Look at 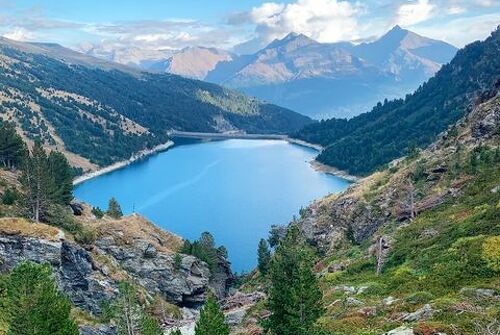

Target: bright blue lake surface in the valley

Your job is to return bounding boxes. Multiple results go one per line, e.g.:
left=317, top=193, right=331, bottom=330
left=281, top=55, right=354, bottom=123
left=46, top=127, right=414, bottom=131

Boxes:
left=75, top=140, right=349, bottom=271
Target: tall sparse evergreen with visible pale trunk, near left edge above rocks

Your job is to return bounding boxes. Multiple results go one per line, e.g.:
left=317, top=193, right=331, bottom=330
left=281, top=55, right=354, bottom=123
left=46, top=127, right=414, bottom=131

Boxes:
left=21, top=142, right=55, bottom=222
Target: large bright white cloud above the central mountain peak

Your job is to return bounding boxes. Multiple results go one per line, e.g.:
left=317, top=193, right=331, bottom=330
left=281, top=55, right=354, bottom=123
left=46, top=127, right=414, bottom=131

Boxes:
left=229, top=0, right=364, bottom=51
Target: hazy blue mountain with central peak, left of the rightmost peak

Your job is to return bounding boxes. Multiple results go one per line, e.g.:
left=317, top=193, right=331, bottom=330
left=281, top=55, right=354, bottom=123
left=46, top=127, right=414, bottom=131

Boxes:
left=206, top=33, right=394, bottom=117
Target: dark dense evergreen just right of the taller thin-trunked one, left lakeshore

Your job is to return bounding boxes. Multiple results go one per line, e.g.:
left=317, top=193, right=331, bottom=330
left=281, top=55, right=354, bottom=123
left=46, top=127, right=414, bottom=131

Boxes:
left=48, top=151, right=73, bottom=205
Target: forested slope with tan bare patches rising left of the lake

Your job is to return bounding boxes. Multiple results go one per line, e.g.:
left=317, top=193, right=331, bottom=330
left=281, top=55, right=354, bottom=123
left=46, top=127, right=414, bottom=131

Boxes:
left=0, top=39, right=310, bottom=168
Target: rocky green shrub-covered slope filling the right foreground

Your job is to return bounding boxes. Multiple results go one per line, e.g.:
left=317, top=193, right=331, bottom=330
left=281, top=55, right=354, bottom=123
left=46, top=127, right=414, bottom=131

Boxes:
left=240, top=89, right=500, bottom=335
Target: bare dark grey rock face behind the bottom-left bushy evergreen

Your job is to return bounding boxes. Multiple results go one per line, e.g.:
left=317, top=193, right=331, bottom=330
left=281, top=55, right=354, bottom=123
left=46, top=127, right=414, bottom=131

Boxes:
left=0, top=234, right=117, bottom=314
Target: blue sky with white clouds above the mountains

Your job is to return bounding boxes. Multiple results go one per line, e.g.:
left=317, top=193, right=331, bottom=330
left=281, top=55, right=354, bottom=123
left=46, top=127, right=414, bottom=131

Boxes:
left=0, top=0, right=500, bottom=52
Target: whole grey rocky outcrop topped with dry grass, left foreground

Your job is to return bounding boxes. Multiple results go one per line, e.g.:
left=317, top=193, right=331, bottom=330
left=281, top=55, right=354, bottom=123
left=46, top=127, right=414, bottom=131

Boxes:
left=0, top=210, right=232, bottom=334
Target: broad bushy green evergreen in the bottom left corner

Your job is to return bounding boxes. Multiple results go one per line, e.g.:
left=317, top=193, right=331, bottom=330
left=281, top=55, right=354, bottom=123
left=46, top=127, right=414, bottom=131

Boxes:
left=5, top=262, right=79, bottom=335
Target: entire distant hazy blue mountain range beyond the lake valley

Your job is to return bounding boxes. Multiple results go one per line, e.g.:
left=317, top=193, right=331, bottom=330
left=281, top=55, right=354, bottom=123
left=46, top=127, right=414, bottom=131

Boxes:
left=81, top=26, right=457, bottom=119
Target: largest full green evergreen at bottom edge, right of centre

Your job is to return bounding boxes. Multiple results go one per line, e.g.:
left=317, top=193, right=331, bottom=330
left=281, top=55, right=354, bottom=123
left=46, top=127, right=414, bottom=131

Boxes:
left=264, top=226, right=324, bottom=335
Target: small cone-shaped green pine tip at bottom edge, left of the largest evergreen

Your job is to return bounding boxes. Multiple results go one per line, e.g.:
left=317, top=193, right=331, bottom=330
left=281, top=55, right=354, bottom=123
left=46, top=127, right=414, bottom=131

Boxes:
left=194, top=296, right=229, bottom=335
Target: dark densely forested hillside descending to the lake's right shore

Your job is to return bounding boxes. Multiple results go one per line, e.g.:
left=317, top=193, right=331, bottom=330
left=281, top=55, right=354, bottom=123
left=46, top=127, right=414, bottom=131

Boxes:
left=294, top=29, right=500, bottom=175
